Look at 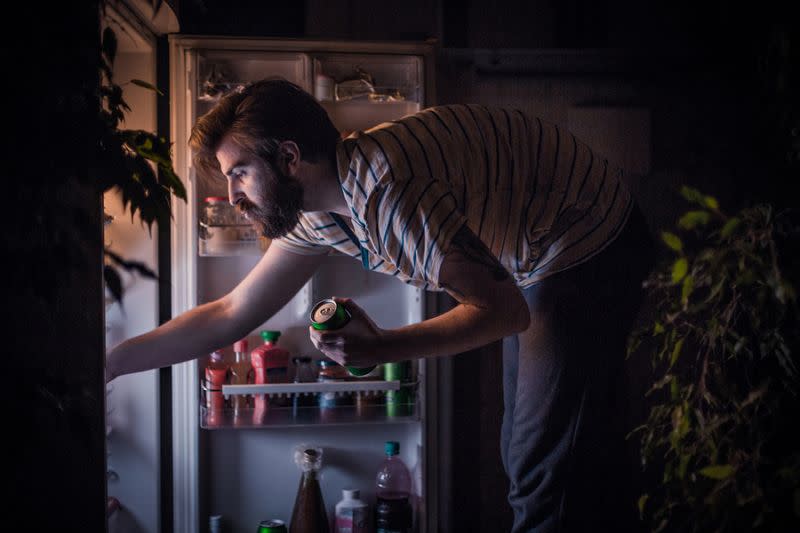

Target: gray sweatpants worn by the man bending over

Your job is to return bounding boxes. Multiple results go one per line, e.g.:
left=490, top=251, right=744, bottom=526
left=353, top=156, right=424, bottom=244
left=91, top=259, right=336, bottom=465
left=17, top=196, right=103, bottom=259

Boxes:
left=501, top=205, right=654, bottom=533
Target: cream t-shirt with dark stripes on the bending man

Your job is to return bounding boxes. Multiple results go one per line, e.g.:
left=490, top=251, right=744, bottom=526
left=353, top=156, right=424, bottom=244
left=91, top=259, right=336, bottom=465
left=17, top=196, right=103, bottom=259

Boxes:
left=274, top=105, right=633, bottom=290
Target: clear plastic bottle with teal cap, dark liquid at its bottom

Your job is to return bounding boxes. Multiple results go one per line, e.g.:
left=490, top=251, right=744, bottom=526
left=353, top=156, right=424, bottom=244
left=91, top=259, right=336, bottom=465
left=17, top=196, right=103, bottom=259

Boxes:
left=375, top=441, right=413, bottom=533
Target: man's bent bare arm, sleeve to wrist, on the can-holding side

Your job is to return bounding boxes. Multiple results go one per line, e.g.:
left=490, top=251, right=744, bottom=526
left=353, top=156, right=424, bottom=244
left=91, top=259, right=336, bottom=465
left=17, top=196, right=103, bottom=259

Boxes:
left=382, top=225, right=530, bottom=361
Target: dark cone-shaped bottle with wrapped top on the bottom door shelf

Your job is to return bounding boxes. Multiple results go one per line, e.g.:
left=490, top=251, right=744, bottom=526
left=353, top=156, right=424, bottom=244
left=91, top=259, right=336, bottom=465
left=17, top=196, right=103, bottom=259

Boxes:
left=289, top=444, right=330, bottom=533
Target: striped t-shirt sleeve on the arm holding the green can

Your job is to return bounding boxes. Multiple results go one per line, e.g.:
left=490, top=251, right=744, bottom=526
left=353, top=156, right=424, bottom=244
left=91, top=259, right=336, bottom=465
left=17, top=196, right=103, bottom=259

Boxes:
left=365, top=176, right=466, bottom=287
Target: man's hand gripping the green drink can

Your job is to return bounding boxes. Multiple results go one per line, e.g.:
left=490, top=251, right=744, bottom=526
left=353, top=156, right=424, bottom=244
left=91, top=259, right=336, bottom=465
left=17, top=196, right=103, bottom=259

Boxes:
left=308, top=297, right=386, bottom=368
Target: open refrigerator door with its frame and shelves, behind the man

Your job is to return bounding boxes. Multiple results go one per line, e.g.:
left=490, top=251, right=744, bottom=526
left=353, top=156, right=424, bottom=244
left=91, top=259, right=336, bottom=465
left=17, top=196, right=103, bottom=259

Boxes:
left=169, top=34, right=441, bottom=533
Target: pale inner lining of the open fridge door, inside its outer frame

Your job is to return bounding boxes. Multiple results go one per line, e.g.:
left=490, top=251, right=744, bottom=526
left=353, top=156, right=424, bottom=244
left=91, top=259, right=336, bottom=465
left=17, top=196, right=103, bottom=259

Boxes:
left=178, top=42, right=432, bottom=532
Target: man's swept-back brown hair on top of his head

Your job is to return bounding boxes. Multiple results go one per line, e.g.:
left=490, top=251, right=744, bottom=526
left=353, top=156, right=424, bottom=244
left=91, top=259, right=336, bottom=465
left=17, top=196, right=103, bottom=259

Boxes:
left=189, top=78, right=339, bottom=177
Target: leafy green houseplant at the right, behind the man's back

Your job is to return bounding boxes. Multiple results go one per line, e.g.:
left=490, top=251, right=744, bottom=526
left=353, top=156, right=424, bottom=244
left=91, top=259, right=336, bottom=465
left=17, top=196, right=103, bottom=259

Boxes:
left=629, top=187, right=800, bottom=532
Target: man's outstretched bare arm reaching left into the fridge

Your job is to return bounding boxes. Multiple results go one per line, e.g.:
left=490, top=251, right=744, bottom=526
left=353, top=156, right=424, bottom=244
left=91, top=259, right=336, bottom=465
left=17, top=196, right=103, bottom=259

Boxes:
left=106, top=246, right=325, bottom=381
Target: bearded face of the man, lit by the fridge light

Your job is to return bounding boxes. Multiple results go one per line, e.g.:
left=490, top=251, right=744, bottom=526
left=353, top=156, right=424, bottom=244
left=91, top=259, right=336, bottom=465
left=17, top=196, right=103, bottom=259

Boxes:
left=217, top=137, right=303, bottom=239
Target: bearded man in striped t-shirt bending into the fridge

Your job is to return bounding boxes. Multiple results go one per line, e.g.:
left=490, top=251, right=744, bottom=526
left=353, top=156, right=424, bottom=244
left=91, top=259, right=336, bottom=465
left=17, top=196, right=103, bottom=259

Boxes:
left=108, top=80, right=650, bottom=531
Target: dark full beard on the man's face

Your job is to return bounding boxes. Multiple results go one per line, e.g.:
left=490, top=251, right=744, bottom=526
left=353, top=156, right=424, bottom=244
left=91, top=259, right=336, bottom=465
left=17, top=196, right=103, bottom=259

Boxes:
left=237, top=169, right=303, bottom=239
